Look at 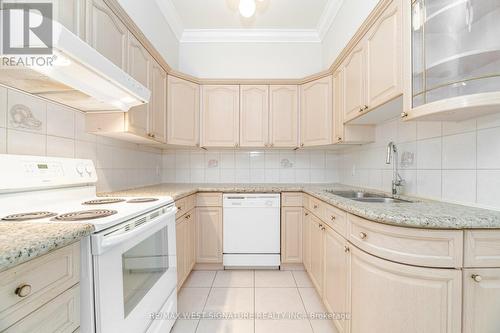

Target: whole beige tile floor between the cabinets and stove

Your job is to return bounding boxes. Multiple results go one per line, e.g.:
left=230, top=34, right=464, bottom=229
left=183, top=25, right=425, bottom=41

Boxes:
left=172, top=270, right=337, bottom=333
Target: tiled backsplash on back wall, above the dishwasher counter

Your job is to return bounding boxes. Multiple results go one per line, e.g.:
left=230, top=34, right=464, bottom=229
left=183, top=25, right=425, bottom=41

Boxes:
left=162, top=150, right=339, bottom=183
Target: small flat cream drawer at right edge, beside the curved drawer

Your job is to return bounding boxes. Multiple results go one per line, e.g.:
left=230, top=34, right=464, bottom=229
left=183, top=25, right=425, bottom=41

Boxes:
left=464, top=230, right=500, bottom=267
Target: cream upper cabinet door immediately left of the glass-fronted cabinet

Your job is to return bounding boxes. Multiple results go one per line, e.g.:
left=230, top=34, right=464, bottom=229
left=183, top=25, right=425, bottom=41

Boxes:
left=365, top=1, right=403, bottom=109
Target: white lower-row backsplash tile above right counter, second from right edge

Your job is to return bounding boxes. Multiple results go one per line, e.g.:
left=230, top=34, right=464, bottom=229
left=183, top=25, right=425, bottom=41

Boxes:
left=442, top=170, right=476, bottom=204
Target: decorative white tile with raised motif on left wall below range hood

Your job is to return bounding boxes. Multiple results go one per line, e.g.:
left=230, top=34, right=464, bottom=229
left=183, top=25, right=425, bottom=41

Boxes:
left=7, top=90, right=47, bottom=134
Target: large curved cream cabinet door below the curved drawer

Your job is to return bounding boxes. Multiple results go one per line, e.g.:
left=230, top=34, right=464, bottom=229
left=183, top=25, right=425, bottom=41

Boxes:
left=350, top=246, right=462, bottom=333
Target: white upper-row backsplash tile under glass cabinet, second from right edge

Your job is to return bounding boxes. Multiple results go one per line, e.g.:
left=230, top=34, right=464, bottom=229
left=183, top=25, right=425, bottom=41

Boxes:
left=443, top=132, right=476, bottom=169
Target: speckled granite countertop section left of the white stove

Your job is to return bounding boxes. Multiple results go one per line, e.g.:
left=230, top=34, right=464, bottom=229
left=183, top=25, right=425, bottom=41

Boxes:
left=0, top=222, right=94, bottom=271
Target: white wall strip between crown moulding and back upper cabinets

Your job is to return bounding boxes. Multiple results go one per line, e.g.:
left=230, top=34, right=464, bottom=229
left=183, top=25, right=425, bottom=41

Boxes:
left=179, top=42, right=323, bottom=79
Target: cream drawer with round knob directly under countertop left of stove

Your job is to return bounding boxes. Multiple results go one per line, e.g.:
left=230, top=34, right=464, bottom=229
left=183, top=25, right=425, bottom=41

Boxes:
left=0, top=243, right=80, bottom=331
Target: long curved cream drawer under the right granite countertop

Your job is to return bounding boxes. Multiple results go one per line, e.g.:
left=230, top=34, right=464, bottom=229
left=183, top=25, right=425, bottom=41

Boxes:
left=348, top=214, right=463, bottom=267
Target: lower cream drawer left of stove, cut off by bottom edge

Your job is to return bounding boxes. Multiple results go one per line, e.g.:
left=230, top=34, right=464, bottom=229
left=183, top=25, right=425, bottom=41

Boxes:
left=3, top=285, right=80, bottom=333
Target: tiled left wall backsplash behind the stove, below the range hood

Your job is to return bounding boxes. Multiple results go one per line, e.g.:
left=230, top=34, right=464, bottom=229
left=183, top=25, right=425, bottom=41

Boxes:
left=0, top=86, right=161, bottom=191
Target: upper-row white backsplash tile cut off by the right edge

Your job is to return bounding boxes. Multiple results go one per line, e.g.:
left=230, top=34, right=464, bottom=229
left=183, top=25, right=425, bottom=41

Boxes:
left=477, top=127, right=500, bottom=169
